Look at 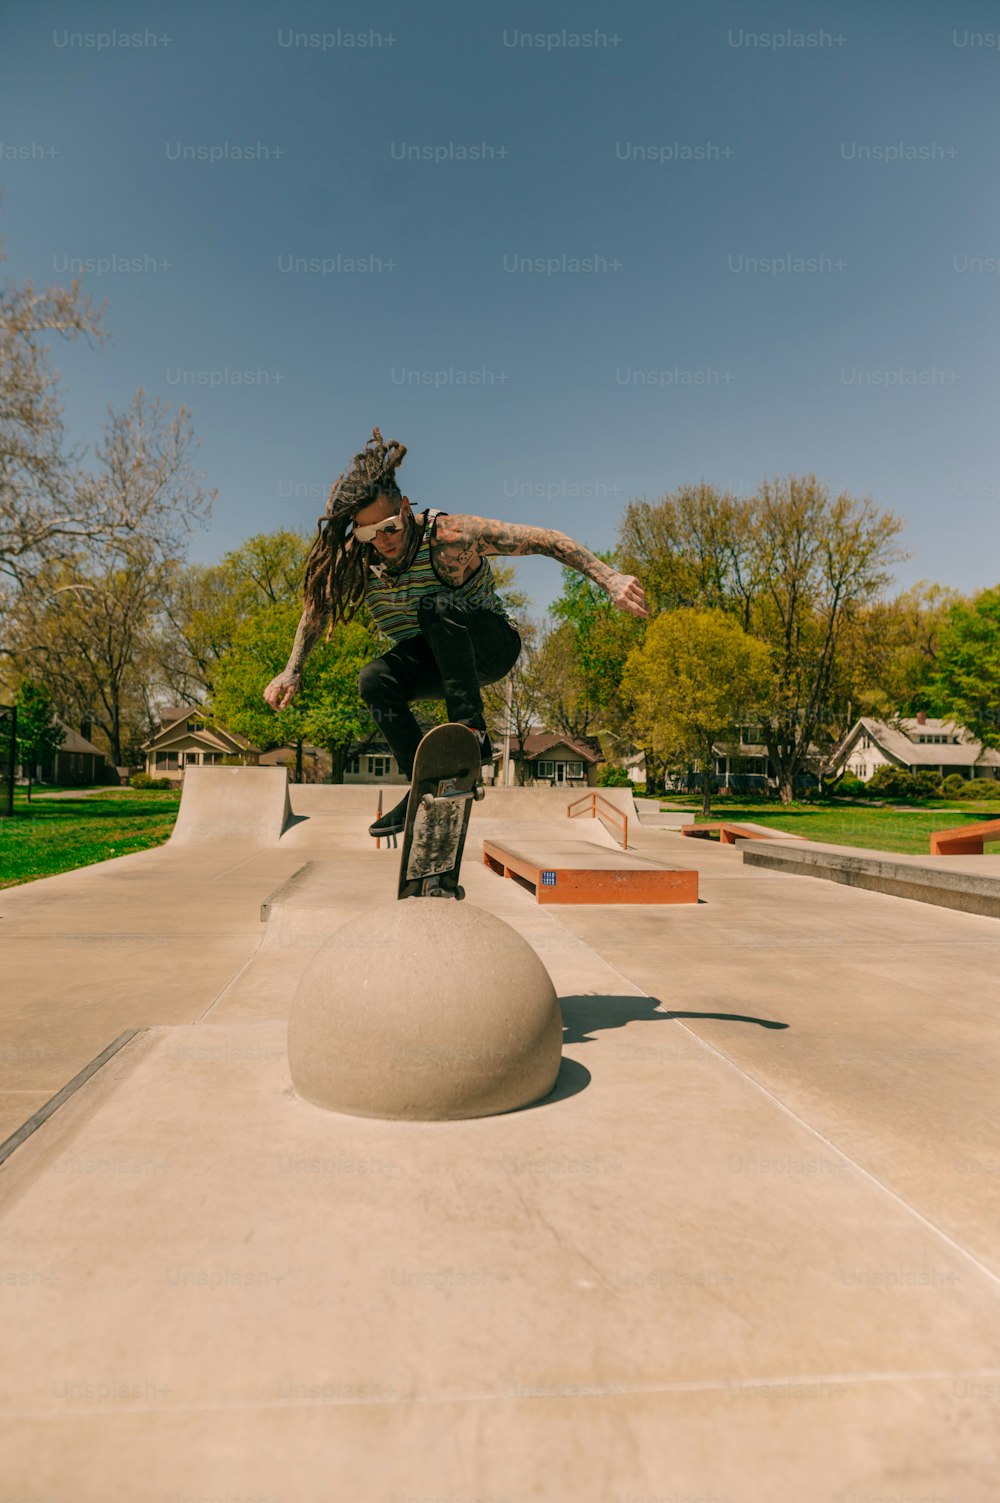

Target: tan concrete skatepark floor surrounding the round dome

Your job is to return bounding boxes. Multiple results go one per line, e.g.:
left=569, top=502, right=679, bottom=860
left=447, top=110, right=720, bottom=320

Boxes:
left=0, top=770, right=1000, bottom=1503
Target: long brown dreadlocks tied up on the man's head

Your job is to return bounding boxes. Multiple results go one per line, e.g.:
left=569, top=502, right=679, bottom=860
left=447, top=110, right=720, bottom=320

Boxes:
left=304, top=428, right=406, bottom=642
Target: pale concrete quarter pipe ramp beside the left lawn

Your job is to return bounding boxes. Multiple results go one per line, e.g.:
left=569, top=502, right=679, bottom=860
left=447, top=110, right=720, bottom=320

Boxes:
left=168, top=767, right=290, bottom=846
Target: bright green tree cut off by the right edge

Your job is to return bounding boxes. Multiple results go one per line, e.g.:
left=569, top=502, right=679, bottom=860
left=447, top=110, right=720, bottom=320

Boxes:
left=926, top=585, right=1000, bottom=747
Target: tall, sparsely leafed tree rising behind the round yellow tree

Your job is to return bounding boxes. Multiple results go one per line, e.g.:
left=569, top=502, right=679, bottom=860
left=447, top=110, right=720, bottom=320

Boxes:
left=621, top=475, right=905, bottom=803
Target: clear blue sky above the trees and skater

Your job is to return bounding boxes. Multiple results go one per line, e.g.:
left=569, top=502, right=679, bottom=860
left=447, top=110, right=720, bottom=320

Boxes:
left=0, top=0, right=1000, bottom=615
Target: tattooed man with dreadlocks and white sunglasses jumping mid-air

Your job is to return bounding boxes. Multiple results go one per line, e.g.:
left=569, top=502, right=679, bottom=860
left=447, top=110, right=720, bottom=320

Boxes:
left=263, top=428, right=650, bottom=836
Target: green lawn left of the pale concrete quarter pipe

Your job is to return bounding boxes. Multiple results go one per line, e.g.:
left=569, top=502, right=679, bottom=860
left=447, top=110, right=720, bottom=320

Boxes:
left=0, top=788, right=180, bottom=888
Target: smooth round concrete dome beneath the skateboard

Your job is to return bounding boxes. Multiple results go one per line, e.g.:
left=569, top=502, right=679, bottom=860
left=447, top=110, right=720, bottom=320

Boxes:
left=289, top=897, right=562, bottom=1120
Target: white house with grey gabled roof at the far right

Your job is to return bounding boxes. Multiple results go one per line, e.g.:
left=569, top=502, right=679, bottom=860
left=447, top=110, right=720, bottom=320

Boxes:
left=829, top=711, right=1000, bottom=783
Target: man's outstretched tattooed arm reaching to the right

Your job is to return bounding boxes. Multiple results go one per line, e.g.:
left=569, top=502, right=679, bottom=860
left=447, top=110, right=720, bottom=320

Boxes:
left=430, top=516, right=650, bottom=616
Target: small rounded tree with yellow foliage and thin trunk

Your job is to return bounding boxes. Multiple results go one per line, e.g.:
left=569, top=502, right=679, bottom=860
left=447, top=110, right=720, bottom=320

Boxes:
left=623, top=607, right=774, bottom=818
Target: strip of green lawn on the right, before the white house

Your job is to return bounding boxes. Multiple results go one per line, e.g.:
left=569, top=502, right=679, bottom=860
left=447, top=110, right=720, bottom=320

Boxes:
left=663, top=794, right=1000, bottom=855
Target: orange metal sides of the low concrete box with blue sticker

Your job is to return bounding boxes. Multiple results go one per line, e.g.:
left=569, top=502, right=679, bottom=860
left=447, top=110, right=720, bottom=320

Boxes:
left=483, top=840, right=698, bottom=903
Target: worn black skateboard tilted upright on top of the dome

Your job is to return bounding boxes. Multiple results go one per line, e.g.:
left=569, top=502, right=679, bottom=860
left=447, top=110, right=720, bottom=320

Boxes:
left=397, top=724, right=486, bottom=897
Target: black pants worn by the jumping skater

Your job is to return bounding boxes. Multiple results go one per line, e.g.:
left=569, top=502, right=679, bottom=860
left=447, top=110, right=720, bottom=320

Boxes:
left=358, top=589, right=520, bottom=777
